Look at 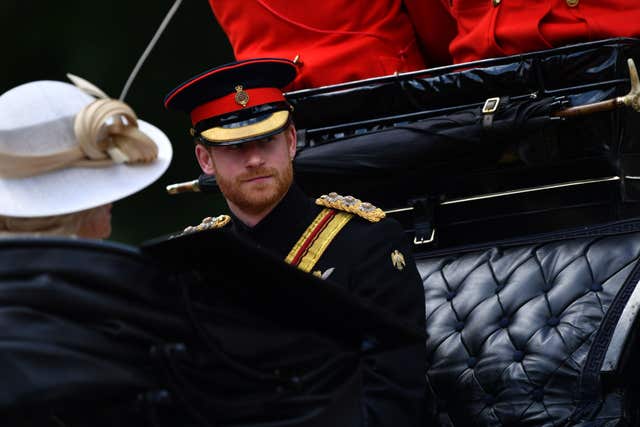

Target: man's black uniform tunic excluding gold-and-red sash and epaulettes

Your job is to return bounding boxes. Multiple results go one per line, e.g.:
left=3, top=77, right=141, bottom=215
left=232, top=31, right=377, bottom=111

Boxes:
left=222, top=185, right=425, bottom=426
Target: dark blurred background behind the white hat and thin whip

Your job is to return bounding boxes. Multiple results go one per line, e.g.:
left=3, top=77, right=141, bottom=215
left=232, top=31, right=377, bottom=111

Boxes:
left=0, top=0, right=235, bottom=244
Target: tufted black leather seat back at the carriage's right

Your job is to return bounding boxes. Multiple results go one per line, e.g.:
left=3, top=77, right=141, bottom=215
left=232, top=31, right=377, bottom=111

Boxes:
left=418, top=226, right=640, bottom=426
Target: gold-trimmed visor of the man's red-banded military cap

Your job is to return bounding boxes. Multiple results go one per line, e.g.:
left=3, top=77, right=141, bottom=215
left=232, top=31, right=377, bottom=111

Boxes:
left=200, top=110, right=291, bottom=147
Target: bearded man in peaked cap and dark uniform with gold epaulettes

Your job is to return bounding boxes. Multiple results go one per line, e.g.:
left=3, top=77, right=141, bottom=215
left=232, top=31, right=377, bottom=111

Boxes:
left=165, top=59, right=426, bottom=426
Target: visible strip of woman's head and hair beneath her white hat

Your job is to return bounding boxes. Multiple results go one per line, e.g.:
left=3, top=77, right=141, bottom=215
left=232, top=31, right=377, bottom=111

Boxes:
left=0, top=208, right=96, bottom=237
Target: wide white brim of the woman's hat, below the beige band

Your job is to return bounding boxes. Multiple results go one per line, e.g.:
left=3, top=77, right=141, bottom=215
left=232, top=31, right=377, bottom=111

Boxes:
left=0, top=120, right=173, bottom=218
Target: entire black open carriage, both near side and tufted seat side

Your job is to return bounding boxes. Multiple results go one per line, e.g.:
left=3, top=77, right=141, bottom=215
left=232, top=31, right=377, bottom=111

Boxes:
left=0, top=39, right=640, bottom=426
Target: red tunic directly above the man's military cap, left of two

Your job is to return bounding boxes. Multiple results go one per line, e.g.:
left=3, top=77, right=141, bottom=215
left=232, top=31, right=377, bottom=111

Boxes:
left=209, top=0, right=425, bottom=90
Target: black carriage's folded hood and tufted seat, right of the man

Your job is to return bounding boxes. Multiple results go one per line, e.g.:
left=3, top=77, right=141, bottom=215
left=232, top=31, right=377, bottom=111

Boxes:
left=290, top=39, right=640, bottom=425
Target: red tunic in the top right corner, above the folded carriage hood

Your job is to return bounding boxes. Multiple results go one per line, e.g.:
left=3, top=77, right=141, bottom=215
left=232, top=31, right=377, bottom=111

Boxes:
left=406, top=0, right=640, bottom=63
